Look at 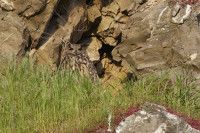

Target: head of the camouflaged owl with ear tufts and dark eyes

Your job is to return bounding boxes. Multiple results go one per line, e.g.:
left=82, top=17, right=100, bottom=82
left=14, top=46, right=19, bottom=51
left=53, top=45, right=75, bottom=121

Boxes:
left=63, top=42, right=86, bottom=55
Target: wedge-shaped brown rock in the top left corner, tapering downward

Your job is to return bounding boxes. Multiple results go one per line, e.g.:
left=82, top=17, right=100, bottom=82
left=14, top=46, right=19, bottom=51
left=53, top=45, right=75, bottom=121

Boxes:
left=0, top=0, right=59, bottom=47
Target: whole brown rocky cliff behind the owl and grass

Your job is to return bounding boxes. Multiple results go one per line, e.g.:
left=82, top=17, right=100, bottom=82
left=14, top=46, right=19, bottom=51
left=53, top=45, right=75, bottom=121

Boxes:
left=0, top=0, right=200, bottom=131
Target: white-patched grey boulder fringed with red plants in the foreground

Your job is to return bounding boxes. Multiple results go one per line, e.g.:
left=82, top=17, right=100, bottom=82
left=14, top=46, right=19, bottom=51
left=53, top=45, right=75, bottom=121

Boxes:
left=116, top=103, right=200, bottom=133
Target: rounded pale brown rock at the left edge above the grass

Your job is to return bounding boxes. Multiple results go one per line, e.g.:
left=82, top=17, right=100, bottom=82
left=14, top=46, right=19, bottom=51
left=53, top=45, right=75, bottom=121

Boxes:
left=0, top=12, right=29, bottom=68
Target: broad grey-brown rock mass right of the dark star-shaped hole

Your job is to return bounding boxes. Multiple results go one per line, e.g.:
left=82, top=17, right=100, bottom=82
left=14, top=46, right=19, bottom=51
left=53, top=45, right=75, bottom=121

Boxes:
left=112, top=0, right=200, bottom=73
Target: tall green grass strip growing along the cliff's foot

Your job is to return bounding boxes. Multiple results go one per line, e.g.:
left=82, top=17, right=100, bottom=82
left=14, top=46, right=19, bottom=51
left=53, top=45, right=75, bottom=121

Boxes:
left=0, top=58, right=200, bottom=133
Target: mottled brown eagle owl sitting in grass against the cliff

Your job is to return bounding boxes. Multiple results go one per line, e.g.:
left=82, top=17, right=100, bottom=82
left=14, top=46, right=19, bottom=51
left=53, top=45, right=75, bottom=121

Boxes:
left=60, top=42, right=99, bottom=83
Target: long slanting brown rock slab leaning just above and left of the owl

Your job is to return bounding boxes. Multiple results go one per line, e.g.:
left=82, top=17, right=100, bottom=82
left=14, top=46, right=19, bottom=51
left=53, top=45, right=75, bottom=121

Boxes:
left=36, top=0, right=88, bottom=64
